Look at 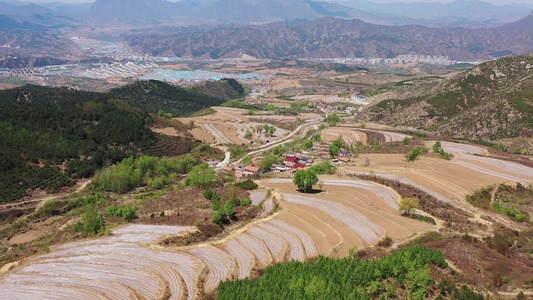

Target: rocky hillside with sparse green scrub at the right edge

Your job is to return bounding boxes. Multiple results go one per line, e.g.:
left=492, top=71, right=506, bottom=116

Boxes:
left=357, top=54, right=533, bottom=140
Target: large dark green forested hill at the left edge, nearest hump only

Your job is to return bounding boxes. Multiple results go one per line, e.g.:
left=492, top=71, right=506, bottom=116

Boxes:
left=0, top=87, right=156, bottom=202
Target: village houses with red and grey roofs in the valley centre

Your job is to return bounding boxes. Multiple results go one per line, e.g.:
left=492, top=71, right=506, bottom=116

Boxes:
left=223, top=144, right=352, bottom=177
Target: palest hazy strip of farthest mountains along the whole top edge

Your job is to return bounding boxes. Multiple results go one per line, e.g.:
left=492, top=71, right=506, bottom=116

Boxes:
left=0, top=0, right=533, bottom=27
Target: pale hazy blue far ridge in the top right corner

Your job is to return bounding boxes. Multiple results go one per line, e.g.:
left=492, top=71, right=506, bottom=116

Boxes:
left=337, top=0, right=533, bottom=25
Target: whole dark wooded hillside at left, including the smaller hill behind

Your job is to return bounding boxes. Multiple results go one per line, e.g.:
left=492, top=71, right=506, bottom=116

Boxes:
left=0, top=79, right=235, bottom=202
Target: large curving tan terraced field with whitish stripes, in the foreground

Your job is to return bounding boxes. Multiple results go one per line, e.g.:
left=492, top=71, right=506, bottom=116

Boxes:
left=0, top=177, right=433, bottom=299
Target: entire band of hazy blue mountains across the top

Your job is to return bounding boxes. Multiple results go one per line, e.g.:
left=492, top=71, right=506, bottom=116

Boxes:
left=0, top=0, right=533, bottom=60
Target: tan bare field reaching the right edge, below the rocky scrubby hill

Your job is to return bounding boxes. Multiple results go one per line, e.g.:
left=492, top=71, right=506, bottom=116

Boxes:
left=340, top=154, right=533, bottom=208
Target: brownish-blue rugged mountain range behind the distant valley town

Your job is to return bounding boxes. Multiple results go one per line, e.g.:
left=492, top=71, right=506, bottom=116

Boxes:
left=126, top=15, right=533, bottom=60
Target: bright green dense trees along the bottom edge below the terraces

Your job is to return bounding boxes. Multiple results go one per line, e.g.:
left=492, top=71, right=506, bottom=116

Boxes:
left=218, top=245, right=470, bottom=300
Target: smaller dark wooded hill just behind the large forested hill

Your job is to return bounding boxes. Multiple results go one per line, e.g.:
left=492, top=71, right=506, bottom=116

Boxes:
left=108, top=79, right=243, bottom=116
